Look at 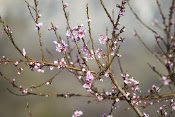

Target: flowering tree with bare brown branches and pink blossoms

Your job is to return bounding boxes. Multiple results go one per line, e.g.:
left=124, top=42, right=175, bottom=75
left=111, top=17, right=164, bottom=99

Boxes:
left=0, top=0, right=175, bottom=117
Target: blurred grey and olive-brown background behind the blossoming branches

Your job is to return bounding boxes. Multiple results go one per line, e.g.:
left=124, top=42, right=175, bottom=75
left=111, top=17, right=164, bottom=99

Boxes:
left=0, top=0, right=171, bottom=117
